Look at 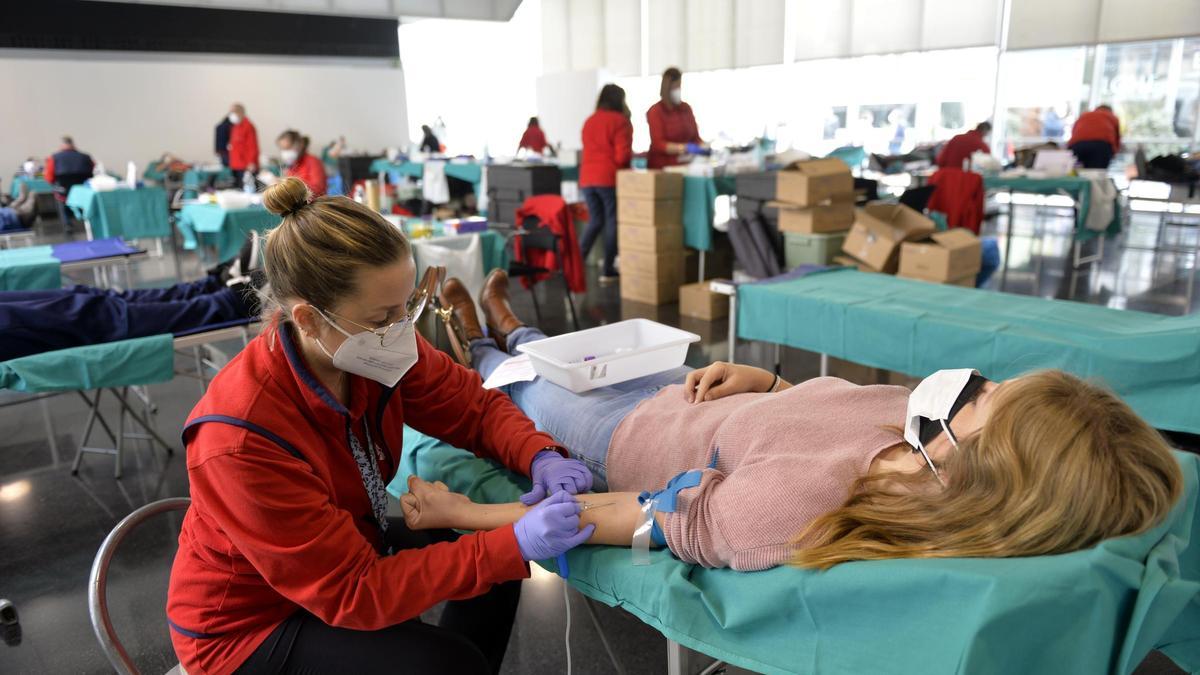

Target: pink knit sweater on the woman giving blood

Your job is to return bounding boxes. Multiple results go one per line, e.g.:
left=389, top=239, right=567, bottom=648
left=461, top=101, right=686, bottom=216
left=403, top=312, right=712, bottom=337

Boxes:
left=607, top=377, right=908, bottom=571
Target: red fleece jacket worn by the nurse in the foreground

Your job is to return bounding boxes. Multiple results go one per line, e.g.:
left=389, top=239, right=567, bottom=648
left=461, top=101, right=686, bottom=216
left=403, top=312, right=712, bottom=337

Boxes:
left=167, top=328, right=556, bottom=674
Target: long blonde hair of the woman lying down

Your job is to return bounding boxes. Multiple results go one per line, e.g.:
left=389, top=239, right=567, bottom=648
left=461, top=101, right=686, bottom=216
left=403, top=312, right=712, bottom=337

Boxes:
left=792, top=370, right=1183, bottom=569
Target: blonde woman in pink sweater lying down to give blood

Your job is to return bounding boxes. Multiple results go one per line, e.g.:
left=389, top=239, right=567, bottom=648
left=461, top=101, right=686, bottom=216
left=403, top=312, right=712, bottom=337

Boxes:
left=420, top=290, right=1183, bottom=571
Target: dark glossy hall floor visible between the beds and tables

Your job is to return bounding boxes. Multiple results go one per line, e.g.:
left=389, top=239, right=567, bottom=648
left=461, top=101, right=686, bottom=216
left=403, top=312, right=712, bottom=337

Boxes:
left=0, top=201, right=1196, bottom=674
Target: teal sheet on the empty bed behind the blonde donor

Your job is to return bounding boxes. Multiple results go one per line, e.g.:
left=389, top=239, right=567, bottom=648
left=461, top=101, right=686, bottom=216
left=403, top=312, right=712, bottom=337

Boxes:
left=737, top=269, right=1200, bottom=434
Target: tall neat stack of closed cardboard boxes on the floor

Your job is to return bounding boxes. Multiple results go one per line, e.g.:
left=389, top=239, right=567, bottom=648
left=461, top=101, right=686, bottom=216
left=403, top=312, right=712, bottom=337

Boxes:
left=617, top=171, right=684, bottom=305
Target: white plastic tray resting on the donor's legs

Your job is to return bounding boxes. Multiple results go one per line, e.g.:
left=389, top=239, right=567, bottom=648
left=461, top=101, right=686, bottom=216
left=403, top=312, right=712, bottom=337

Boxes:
left=517, top=318, right=700, bottom=394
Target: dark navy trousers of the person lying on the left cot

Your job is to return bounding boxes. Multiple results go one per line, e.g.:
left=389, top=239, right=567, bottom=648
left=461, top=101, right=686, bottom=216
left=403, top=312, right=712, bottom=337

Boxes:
left=0, top=276, right=248, bottom=360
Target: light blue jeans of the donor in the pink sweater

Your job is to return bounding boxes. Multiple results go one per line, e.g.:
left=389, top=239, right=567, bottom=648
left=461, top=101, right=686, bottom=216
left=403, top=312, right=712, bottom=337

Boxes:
left=470, top=327, right=691, bottom=485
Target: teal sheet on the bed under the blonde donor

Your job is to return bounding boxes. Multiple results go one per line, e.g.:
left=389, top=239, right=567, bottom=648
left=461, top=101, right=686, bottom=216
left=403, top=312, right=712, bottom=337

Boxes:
left=388, top=428, right=1200, bottom=675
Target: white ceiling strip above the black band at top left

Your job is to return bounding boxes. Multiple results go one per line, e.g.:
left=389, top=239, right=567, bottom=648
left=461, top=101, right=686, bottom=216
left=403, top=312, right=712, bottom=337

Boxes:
left=90, top=0, right=521, bottom=22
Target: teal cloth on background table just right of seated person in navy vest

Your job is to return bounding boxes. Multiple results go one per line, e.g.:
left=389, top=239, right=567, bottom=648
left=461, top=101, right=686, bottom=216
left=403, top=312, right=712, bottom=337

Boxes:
left=67, top=185, right=170, bottom=239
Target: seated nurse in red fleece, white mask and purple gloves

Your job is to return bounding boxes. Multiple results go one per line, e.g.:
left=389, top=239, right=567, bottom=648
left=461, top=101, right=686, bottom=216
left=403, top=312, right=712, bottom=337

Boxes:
left=167, top=178, right=592, bottom=675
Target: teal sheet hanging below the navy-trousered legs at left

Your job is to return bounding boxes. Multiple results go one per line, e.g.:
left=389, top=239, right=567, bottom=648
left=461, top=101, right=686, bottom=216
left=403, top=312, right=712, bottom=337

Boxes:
left=0, top=334, right=175, bottom=393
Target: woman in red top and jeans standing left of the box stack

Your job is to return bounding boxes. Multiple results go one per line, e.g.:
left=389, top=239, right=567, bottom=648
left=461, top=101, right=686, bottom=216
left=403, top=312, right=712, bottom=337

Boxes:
left=580, top=84, right=634, bottom=285
